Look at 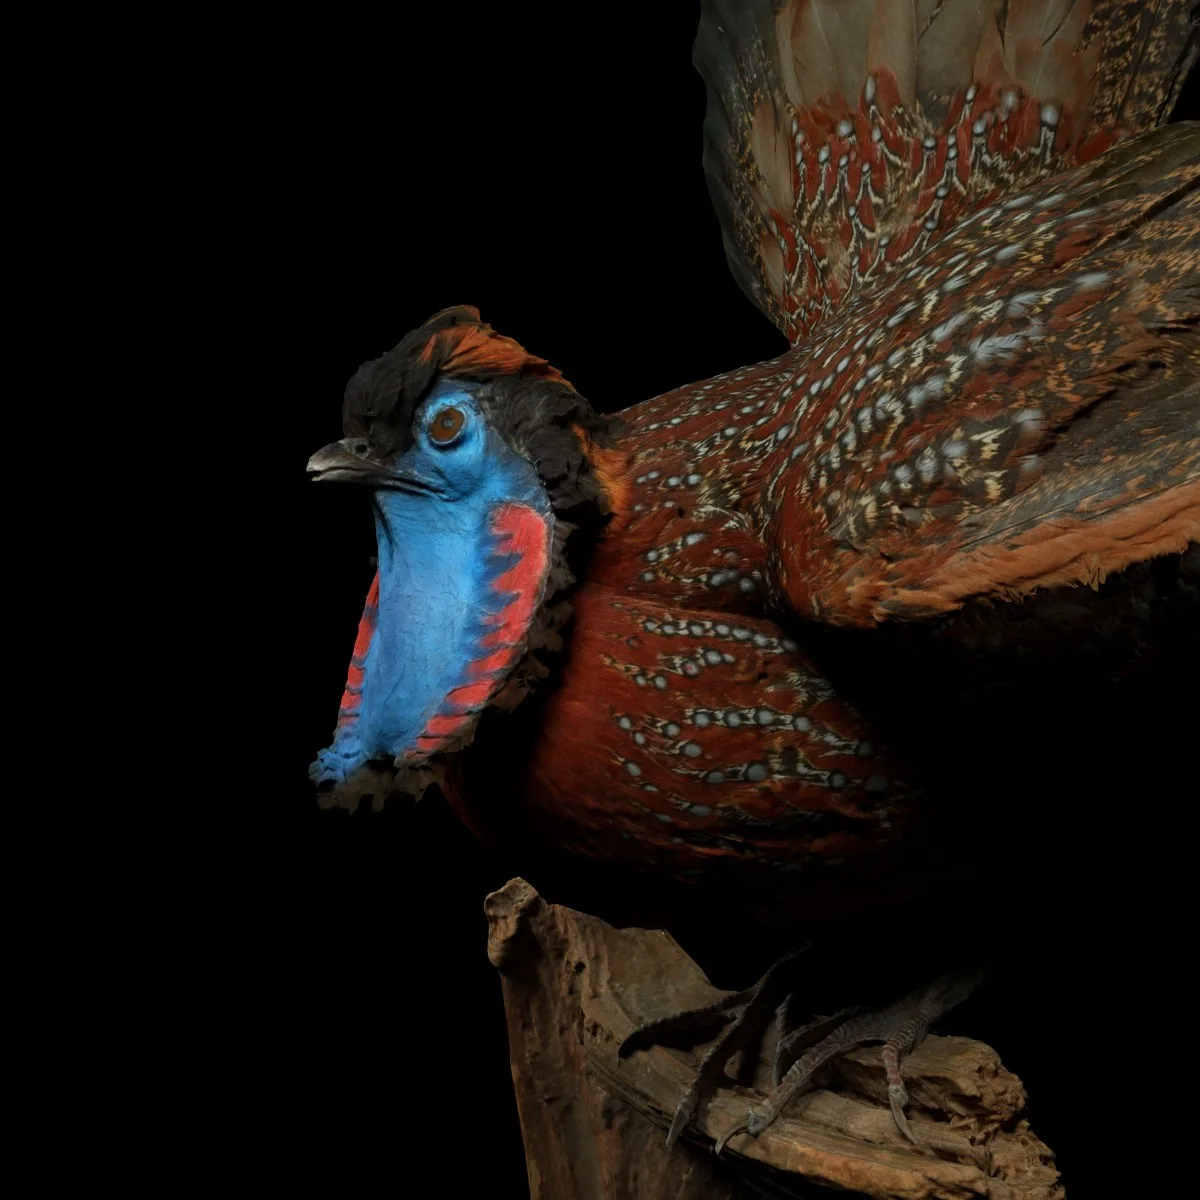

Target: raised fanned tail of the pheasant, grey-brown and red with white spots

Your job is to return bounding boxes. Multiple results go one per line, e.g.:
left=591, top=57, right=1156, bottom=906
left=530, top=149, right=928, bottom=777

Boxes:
left=695, top=0, right=1198, bottom=341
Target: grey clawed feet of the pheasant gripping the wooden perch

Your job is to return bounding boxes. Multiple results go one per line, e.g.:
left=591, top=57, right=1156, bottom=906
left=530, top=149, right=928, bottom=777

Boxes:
left=618, top=947, right=982, bottom=1154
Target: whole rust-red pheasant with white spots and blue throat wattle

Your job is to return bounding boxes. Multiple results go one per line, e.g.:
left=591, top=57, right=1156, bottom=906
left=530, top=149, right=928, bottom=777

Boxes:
left=308, top=0, right=1200, bottom=1156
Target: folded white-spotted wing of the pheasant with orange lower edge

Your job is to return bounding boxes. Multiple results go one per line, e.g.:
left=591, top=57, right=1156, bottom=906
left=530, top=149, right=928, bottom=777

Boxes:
left=762, top=124, right=1200, bottom=625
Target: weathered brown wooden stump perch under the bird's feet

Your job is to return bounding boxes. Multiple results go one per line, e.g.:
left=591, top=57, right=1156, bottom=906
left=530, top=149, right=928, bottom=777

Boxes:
left=486, top=880, right=1064, bottom=1200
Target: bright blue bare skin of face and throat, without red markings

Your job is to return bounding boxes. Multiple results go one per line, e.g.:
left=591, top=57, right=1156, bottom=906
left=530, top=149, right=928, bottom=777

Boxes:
left=310, top=380, right=551, bottom=786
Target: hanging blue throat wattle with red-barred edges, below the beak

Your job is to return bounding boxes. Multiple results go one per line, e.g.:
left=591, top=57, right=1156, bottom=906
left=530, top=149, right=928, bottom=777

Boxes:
left=310, top=417, right=553, bottom=787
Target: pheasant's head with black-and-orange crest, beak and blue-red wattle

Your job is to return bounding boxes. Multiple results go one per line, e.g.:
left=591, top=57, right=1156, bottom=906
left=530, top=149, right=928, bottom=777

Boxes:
left=308, top=307, right=606, bottom=808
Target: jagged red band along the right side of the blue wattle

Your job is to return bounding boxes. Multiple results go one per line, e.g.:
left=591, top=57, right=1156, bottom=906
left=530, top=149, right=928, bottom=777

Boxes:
left=416, top=504, right=550, bottom=754
